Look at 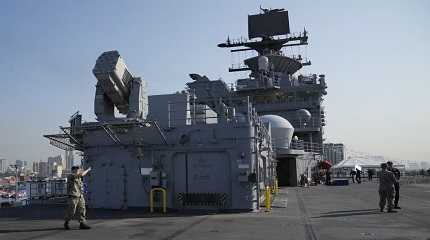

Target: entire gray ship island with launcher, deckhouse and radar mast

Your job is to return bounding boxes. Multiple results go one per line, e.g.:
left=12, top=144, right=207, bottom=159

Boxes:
left=45, top=9, right=326, bottom=210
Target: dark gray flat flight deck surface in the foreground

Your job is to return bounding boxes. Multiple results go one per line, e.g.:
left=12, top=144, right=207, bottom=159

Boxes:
left=0, top=182, right=430, bottom=240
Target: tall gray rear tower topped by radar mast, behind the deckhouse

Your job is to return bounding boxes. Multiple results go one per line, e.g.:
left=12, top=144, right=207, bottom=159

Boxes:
left=191, top=9, right=327, bottom=186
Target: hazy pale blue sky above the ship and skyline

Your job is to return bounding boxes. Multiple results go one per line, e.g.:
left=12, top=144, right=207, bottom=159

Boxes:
left=0, top=0, right=430, bottom=164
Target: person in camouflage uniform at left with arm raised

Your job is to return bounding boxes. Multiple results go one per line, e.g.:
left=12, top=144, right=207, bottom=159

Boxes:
left=64, top=166, right=91, bottom=230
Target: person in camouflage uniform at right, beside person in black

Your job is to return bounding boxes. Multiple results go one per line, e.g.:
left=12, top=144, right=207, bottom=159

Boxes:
left=379, top=163, right=397, bottom=212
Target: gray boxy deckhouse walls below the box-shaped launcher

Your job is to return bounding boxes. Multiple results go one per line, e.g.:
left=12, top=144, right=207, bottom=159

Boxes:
left=83, top=98, right=275, bottom=210
